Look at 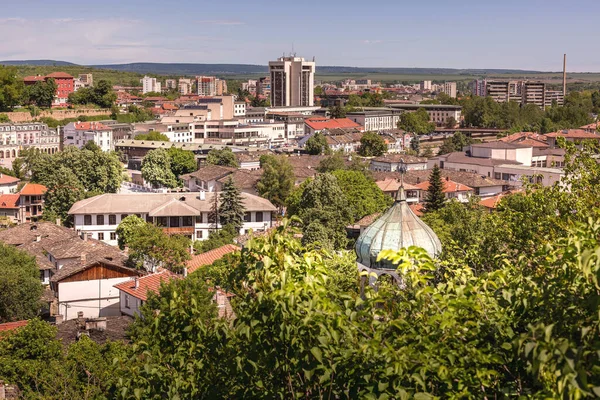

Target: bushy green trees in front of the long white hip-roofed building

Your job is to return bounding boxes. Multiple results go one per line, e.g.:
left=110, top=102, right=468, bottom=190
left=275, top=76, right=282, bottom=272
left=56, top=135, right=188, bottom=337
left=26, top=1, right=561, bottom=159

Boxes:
left=126, top=223, right=190, bottom=272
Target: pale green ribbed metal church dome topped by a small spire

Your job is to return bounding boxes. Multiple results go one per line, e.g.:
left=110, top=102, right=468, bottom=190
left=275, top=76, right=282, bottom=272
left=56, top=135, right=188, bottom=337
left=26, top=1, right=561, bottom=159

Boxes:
left=355, top=187, right=442, bottom=270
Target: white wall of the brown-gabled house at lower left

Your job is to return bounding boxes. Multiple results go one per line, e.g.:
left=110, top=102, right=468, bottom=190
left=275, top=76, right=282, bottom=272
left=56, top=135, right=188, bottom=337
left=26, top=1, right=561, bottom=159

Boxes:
left=58, top=277, right=131, bottom=320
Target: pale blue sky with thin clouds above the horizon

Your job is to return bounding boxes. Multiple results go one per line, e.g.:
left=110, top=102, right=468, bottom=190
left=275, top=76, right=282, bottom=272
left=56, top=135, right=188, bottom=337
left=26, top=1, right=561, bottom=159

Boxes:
left=0, top=0, right=600, bottom=72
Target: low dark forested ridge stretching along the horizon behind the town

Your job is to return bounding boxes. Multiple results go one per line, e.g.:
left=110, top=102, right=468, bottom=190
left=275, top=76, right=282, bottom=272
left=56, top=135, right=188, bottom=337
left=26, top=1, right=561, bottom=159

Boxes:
left=0, top=60, right=540, bottom=75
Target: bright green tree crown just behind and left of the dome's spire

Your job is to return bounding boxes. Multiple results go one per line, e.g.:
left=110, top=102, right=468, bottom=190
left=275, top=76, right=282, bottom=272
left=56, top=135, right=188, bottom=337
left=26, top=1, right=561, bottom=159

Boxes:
left=332, top=170, right=392, bottom=222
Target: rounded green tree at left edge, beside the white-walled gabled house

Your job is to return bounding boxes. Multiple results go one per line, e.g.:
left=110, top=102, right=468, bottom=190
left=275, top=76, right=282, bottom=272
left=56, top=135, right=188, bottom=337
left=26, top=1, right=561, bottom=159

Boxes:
left=0, top=243, right=43, bottom=323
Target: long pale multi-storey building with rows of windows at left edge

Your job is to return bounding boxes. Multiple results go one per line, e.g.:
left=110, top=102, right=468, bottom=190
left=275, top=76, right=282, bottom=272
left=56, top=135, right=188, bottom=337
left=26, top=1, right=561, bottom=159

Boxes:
left=0, top=122, right=61, bottom=168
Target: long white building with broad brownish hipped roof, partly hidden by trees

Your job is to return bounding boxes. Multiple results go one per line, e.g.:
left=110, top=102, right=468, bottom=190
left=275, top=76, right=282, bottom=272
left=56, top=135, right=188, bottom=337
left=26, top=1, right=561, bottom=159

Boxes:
left=69, top=191, right=277, bottom=246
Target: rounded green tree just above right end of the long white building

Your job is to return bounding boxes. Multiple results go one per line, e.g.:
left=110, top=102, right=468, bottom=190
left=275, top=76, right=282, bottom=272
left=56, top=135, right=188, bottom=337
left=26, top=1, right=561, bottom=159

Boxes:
left=256, top=156, right=296, bottom=209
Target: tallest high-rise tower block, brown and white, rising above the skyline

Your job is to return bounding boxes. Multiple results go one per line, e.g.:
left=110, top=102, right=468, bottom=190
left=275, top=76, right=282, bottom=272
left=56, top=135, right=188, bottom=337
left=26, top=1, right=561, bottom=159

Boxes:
left=269, top=56, right=315, bottom=107
